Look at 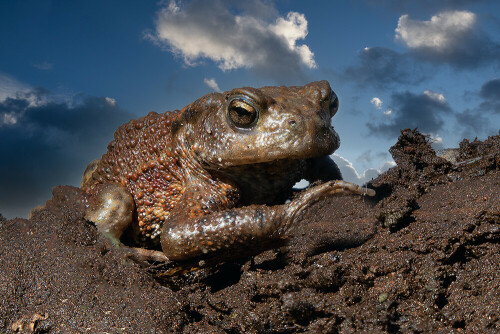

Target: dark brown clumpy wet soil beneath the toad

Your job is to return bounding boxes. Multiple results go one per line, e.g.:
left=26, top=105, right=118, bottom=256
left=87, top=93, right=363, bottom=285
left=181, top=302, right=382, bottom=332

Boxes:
left=0, top=129, right=500, bottom=333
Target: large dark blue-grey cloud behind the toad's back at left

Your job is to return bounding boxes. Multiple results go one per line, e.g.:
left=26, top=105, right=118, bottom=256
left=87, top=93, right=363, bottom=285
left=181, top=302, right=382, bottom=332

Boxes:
left=0, top=89, right=132, bottom=217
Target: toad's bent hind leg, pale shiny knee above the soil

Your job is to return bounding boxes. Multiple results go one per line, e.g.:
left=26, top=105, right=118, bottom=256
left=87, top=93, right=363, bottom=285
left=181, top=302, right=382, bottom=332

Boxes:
left=85, top=183, right=134, bottom=243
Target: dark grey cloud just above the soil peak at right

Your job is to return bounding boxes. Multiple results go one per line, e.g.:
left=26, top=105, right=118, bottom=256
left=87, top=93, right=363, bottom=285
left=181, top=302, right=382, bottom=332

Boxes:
left=367, top=91, right=452, bottom=138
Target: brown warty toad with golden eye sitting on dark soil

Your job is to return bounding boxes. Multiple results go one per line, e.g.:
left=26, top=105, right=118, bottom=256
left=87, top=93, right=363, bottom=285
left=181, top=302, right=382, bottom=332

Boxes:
left=81, top=81, right=374, bottom=261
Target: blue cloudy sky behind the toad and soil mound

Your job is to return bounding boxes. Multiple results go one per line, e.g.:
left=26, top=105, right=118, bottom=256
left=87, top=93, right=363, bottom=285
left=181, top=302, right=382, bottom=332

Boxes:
left=0, top=0, right=500, bottom=217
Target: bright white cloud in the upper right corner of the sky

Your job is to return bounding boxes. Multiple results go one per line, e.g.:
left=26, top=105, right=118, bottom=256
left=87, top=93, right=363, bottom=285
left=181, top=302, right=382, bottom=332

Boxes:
left=395, top=11, right=476, bottom=51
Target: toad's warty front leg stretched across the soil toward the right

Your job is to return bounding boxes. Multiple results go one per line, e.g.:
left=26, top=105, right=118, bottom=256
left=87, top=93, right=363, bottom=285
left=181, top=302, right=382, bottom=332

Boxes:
left=161, top=181, right=375, bottom=261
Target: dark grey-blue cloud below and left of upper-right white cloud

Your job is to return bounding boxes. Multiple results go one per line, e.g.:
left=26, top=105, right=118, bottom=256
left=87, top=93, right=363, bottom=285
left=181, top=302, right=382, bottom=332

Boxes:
left=343, top=47, right=427, bottom=89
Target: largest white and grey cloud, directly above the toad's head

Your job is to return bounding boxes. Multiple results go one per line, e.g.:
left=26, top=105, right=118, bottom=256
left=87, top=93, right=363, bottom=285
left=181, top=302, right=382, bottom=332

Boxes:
left=146, top=0, right=317, bottom=81
